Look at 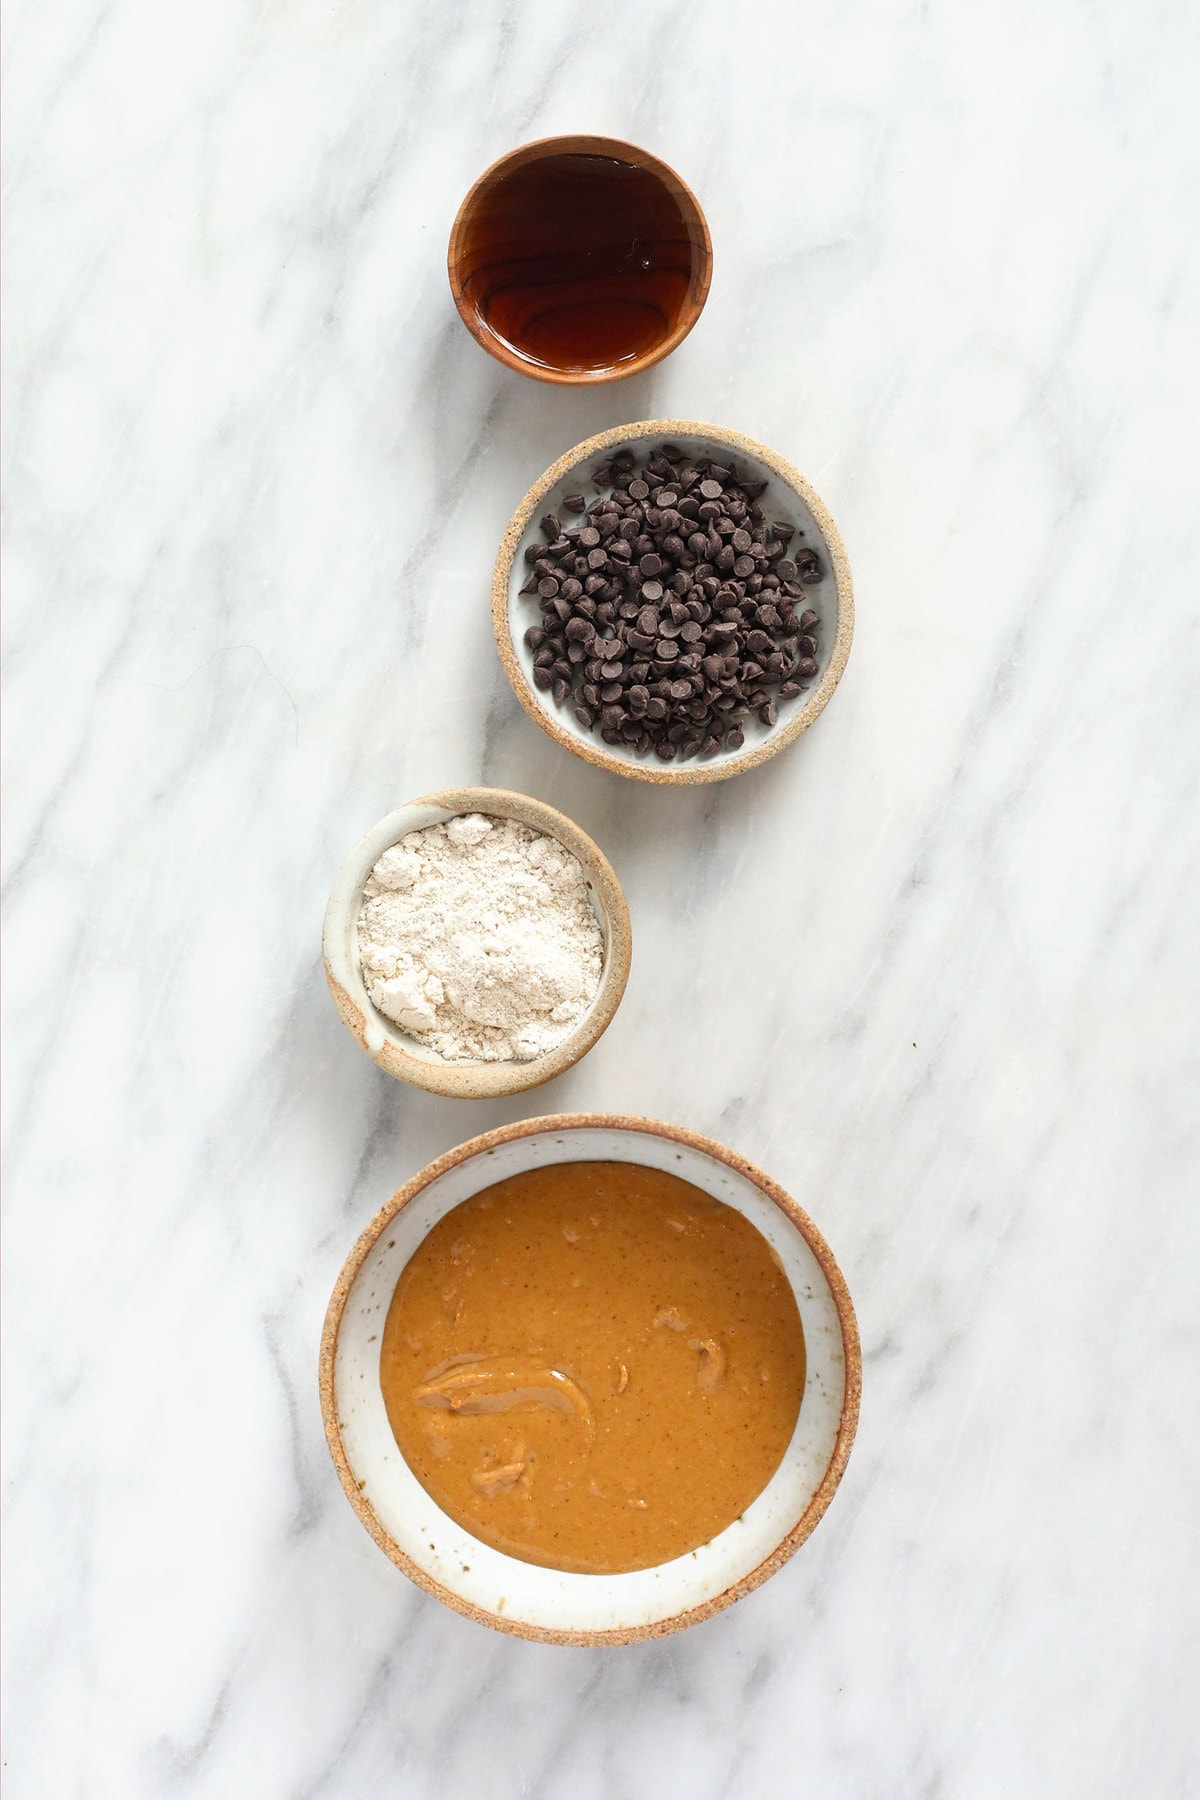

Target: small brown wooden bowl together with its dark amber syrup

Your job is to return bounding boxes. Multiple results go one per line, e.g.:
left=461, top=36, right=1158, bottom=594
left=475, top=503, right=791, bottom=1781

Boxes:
left=448, top=137, right=712, bottom=385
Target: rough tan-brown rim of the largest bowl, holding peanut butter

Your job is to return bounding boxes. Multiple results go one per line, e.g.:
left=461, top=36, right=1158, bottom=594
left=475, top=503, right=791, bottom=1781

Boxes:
left=318, top=1112, right=862, bottom=1645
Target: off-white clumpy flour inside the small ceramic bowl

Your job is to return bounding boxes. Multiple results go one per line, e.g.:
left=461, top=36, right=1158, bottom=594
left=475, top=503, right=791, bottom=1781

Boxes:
left=358, top=812, right=604, bottom=1062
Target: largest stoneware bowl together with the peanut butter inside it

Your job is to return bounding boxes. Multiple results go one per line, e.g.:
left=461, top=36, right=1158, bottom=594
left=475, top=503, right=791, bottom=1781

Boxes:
left=320, top=1112, right=862, bottom=1645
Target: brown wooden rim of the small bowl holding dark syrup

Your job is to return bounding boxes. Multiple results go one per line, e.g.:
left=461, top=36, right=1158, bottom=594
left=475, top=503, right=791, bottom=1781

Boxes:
left=446, top=133, right=712, bottom=387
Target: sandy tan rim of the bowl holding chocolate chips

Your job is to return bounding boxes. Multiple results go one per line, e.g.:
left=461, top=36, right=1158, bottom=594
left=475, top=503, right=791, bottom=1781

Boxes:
left=491, top=419, right=855, bottom=787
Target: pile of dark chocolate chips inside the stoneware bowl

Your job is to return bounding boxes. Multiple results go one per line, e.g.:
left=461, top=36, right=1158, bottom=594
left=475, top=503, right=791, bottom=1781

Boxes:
left=522, top=448, right=824, bottom=761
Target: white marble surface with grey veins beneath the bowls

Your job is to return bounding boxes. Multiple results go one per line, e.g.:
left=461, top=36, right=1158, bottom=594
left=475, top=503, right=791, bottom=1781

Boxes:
left=5, top=0, right=1200, bottom=1800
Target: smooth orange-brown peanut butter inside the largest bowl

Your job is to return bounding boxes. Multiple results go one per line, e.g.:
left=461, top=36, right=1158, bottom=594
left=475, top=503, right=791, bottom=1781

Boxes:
left=380, top=1163, right=804, bottom=1573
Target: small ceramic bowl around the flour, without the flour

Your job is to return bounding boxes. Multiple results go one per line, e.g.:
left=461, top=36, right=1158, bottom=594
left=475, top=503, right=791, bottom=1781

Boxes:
left=324, top=788, right=633, bottom=1100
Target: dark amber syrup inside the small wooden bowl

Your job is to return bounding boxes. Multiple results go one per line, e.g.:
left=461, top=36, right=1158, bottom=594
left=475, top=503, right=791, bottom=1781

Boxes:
left=462, top=155, right=703, bottom=373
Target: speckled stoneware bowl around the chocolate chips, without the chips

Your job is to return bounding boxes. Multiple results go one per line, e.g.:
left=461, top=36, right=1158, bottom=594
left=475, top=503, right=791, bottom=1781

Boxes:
left=491, top=419, right=855, bottom=787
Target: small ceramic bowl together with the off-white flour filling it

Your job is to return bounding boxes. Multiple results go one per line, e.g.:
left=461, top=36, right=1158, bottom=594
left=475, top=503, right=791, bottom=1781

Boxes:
left=324, top=788, right=631, bottom=1100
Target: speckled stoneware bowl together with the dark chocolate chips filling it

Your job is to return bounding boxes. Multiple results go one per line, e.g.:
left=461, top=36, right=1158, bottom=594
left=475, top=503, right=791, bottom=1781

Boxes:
left=491, top=419, right=855, bottom=783
